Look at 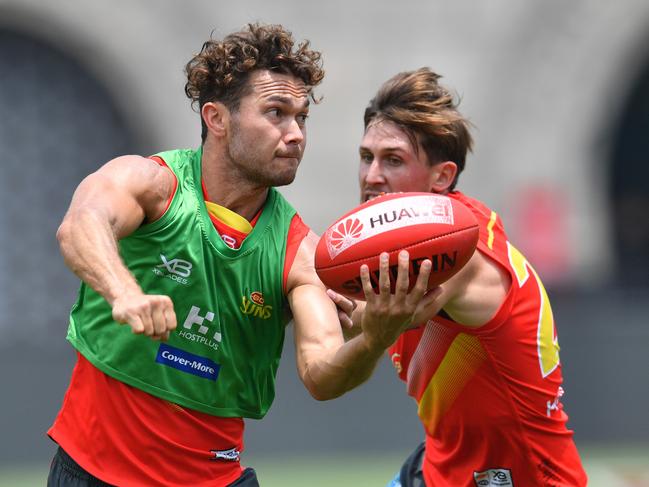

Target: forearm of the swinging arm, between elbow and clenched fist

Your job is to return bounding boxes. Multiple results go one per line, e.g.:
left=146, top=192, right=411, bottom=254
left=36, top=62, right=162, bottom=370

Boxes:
left=57, top=209, right=141, bottom=305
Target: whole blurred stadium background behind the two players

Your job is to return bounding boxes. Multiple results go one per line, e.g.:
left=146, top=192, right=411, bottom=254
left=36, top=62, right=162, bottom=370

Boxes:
left=0, top=0, right=649, bottom=487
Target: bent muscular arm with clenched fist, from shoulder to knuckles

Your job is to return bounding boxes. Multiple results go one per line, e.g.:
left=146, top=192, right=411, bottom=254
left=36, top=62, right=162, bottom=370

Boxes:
left=57, top=156, right=175, bottom=337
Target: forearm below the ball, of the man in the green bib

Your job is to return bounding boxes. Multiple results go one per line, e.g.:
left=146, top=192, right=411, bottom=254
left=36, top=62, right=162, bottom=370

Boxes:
left=302, top=333, right=384, bottom=401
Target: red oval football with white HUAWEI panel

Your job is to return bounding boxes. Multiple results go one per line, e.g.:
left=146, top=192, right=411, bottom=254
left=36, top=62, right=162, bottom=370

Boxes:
left=315, top=193, right=478, bottom=299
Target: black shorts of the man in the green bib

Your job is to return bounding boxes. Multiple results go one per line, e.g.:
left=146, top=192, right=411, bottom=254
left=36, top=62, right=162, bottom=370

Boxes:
left=47, top=447, right=259, bottom=487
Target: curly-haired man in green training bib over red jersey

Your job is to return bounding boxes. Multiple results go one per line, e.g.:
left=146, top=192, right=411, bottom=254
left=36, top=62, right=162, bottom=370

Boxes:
left=48, top=24, right=434, bottom=487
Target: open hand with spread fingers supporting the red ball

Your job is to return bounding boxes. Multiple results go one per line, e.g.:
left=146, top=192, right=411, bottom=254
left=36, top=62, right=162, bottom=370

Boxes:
left=360, top=250, right=441, bottom=349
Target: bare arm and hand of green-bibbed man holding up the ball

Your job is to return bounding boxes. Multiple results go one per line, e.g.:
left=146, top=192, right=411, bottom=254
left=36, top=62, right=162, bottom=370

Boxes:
left=287, top=233, right=429, bottom=400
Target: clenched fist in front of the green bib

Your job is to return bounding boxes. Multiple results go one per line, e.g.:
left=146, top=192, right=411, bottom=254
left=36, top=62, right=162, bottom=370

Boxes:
left=113, top=294, right=176, bottom=341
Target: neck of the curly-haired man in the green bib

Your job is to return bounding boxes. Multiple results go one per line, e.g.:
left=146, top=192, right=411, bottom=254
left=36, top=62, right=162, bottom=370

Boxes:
left=201, top=144, right=268, bottom=221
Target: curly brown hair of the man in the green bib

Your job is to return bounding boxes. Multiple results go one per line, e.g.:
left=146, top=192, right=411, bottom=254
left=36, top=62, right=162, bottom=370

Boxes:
left=185, top=23, right=324, bottom=142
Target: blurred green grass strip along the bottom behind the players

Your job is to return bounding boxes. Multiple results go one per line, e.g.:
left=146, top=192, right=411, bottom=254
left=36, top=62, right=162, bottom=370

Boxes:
left=0, top=445, right=649, bottom=487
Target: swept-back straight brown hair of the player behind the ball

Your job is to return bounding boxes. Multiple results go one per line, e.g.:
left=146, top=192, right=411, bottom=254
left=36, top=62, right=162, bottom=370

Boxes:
left=364, top=68, right=473, bottom=190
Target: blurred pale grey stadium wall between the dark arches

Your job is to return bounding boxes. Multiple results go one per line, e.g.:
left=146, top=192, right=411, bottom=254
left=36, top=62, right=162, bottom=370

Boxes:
left=0, top=0, right=649, bottom=290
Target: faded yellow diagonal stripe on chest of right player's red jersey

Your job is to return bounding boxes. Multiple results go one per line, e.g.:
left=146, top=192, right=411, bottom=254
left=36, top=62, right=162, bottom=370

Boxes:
left=417, top=333, right=487, bottom=435
